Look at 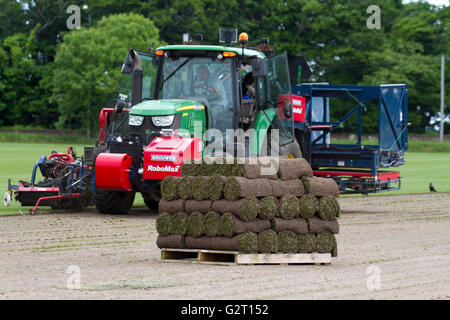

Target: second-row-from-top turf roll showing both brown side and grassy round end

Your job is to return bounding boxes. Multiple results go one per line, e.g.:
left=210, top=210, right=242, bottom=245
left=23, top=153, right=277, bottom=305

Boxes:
left=223, top=177, right=273, bottom=201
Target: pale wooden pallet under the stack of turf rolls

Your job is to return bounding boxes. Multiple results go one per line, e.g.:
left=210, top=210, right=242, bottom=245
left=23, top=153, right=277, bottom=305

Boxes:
left=161, top=249, right=331, bottom=265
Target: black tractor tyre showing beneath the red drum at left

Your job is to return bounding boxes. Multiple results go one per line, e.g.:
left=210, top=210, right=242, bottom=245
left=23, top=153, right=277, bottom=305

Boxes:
left=94, top=190, right=136, bottom=214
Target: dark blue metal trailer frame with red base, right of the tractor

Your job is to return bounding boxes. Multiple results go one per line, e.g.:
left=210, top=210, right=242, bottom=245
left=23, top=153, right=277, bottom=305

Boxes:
left=292, top=84, right=408, bottom=194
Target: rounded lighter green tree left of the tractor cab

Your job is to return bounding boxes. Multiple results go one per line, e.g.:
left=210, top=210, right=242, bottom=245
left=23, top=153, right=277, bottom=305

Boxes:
left=52, top=14, right=161, bottom=132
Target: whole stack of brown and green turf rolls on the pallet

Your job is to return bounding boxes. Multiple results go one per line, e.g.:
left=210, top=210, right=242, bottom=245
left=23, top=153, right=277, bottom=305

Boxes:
left=156, top=157, right=340, bottom=257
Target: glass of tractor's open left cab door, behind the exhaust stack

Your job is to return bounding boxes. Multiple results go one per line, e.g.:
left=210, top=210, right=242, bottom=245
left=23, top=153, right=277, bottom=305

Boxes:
left=119, top=52, right=156, bottom=104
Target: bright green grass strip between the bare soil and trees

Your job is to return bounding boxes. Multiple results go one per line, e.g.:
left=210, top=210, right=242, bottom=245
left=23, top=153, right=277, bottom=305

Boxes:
left=0, top=142, right=450, bottom=214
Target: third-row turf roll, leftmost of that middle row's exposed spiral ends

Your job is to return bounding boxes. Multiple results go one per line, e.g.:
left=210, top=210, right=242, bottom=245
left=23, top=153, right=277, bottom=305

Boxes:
left=211, top=197, right=261, bottom=221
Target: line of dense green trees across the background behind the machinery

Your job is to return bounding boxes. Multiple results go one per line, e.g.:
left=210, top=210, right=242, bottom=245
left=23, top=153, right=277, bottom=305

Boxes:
left=0, top=0, right=450, bottom=134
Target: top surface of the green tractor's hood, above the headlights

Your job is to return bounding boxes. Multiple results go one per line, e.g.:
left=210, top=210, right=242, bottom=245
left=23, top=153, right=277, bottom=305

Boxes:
left=130, top=99, right=204, bottom=116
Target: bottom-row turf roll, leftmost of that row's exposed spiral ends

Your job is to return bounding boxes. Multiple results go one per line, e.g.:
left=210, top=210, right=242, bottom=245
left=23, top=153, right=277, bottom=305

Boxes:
left=211, top=232, right=258, bottom=253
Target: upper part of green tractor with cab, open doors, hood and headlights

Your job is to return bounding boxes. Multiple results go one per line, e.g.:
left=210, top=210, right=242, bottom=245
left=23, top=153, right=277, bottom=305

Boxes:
left=104, top=31, right=301, bottom=157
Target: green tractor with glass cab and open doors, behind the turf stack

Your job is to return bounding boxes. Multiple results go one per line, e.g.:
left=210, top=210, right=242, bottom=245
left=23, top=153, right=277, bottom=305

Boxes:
left=94, top=33, right=302, bottom=213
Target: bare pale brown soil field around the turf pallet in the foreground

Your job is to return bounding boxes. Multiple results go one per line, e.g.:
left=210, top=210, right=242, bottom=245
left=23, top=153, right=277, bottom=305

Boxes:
left=0, top=193, right=450, bottom=299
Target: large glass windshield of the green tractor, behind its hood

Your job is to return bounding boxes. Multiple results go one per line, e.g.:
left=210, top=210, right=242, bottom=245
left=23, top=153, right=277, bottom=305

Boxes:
left=158, top=57, right=233, bottom=133
